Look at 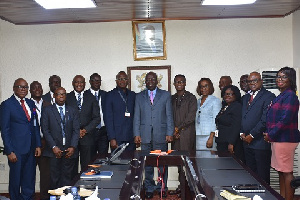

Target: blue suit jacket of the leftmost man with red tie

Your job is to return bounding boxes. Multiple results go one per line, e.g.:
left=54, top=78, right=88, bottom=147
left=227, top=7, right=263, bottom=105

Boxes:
left=1, top=95, right=41, bottom=155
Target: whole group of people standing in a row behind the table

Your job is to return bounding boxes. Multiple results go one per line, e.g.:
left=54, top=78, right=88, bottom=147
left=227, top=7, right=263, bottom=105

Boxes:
left=0, top=67, right=300, bottom=199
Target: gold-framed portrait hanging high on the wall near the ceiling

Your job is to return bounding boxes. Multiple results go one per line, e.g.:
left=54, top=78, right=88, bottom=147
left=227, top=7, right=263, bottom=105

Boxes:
left=132, top=21, right=167, bottom=61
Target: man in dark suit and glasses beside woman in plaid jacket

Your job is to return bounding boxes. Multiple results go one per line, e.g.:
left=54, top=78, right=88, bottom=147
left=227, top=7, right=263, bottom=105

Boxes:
left=240, top=72, right=275, bottom=184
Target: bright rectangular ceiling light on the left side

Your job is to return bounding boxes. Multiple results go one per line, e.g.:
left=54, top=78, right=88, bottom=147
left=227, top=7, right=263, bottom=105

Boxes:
left=34, top=0, right=96, bottom=9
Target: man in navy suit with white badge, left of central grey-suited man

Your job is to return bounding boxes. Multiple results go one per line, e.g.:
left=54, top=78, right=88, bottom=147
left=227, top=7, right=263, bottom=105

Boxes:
left=105, top=71, right=135, bottom=151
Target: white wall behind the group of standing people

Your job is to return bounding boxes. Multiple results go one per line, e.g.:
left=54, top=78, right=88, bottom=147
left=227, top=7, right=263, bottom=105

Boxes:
left=0, top=16, right=299, bottom=192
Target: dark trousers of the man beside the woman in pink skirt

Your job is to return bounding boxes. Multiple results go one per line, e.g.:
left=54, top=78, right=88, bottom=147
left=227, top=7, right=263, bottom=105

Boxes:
left=244, top=147, right=271, bottom=184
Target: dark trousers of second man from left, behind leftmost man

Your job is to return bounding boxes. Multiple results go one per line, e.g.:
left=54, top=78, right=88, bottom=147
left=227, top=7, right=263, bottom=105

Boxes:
left=36, top=139, right=50, bottom=199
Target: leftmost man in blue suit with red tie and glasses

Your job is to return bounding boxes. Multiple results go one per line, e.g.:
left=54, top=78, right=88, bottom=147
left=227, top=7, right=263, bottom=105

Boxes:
left=1, top=78, right=41, bottom=199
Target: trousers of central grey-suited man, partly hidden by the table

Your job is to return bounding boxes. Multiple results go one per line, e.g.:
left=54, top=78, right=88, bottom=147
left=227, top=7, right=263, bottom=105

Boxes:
left=141, top=143, right=168, bottom=192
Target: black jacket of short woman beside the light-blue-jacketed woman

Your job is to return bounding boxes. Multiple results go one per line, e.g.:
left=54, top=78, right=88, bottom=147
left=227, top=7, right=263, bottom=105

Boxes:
left=216, top=101, right=242, bottom=146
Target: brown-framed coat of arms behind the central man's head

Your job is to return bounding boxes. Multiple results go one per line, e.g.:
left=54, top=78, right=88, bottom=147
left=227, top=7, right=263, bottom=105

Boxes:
left=127, top=65, right=171, bottom=93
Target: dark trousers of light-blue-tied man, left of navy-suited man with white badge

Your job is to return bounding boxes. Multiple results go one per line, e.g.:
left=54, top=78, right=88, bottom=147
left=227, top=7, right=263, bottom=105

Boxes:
left=95, top=126, right=109, bottom=156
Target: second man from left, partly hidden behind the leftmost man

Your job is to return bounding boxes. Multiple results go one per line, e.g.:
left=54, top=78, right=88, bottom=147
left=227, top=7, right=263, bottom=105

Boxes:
left=30, top=81, right=51, bottom=200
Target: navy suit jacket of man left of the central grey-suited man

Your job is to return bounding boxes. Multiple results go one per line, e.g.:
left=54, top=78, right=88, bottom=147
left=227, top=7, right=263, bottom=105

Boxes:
left=104, top=88, right=135, bottom=143
